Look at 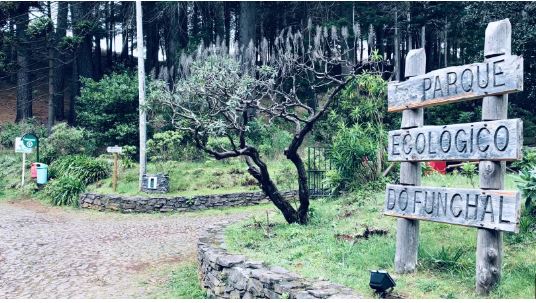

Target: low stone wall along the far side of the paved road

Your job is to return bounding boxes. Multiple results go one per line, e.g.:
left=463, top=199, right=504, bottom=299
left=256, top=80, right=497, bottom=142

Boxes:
left=79, top=191, right=296, bottom=213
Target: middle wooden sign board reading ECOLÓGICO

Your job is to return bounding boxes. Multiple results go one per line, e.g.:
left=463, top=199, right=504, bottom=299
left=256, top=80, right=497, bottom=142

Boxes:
left=387, top=119, right=523, bottom=161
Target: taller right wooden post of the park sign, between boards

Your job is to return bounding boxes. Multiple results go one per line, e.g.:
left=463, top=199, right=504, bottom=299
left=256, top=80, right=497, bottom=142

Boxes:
left=476, top=19, right=512, bottom=295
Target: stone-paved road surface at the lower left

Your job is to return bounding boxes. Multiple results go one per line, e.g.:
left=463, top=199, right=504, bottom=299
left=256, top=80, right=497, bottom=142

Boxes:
left=0, top=201, right=251, bottom=299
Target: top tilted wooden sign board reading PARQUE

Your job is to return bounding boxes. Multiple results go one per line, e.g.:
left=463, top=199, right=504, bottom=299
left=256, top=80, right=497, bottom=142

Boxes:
left=387, top=55, right=523, bottom=112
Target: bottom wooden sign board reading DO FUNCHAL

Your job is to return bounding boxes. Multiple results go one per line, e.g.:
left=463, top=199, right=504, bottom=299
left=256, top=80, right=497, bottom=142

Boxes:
left=384, top=185, right=520, bottom=233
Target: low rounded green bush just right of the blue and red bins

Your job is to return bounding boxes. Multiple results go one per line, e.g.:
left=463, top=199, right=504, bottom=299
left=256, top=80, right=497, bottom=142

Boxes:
left=50, top=155, right=110, bottom=185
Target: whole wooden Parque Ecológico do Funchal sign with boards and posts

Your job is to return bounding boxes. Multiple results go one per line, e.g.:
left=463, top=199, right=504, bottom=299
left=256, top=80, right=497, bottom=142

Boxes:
left=384, top=19, right=523, bottom=294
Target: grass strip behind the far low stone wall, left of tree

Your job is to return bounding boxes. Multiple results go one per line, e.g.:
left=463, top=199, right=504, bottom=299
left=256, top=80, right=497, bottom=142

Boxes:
left=87, top=159, right=293, bottom=196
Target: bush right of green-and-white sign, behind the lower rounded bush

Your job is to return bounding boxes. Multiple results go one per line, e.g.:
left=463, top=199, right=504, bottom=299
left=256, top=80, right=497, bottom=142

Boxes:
left=41, top=123, right=97, bottom=163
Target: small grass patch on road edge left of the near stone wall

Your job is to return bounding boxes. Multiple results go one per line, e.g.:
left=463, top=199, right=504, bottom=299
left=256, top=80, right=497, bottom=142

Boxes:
left=155, top=262, right=206, bottom=299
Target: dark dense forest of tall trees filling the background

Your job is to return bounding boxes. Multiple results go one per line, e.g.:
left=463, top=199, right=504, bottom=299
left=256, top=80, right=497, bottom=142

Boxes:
left=0, top=1, right=536, bottom=144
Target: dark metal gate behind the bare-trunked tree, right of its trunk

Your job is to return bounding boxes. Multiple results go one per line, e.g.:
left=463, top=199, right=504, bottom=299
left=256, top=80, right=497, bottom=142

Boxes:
left=307, top=147, right=331, bottom=197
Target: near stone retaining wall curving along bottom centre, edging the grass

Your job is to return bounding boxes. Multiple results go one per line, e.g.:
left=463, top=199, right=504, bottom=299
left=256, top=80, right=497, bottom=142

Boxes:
left=197, top=224, right=361, bottom=299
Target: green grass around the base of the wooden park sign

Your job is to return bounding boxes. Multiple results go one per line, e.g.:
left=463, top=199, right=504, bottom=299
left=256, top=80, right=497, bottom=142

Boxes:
left=226, top=175, right=536, bottom=298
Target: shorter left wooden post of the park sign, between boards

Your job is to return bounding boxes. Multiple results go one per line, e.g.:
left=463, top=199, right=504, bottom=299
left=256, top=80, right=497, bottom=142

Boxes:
left=395, top=48, right=426, bottom=273
